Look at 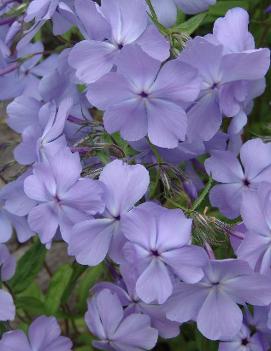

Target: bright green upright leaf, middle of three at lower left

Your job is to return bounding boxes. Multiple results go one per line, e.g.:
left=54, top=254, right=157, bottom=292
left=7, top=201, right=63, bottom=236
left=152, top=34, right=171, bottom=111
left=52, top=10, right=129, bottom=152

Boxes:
left=45, top=264, right=73, bottom=314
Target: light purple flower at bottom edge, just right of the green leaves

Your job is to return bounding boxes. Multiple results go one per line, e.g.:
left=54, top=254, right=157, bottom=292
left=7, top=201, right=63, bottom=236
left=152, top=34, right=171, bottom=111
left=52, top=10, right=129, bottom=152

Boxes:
left=85, top=289, right=158, bottom=351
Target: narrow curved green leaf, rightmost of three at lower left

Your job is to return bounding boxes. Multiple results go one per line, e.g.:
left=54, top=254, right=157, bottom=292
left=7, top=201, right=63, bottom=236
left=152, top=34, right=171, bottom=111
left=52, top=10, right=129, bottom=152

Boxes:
left=77, top=263, right=104, bottom=312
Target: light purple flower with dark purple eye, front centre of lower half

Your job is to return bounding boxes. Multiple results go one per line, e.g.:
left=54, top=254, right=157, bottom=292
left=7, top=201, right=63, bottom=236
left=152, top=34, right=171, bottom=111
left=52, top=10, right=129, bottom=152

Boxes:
left=121, top=203, right=207, bottom=304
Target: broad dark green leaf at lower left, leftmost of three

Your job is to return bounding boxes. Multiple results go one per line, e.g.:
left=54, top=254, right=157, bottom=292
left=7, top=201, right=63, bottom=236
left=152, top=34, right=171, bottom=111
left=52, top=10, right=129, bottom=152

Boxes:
left=9, top=241, right=47, bottom=294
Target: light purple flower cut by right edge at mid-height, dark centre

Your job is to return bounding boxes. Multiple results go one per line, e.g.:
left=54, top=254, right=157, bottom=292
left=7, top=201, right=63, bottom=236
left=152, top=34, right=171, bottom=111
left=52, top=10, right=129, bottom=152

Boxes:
left=205, top=139, right=271, bottom=218
